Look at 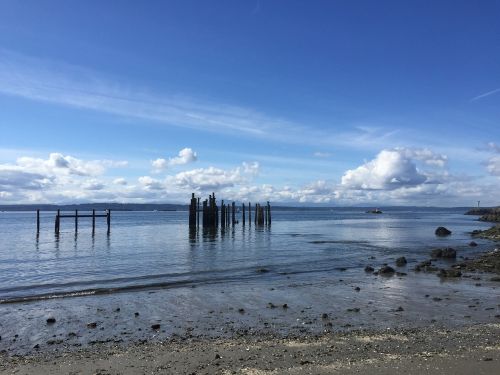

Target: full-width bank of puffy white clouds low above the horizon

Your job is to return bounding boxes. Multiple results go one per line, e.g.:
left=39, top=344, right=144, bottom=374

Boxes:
left=0, top=145, right=500, bottom=205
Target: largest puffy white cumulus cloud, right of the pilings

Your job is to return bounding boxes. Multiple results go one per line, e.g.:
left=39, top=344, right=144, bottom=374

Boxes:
left=341, top=149, right=427, bottom=190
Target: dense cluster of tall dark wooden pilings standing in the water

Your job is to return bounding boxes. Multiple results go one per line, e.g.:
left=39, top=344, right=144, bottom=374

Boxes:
left=189, top=193, right=271, bottom=227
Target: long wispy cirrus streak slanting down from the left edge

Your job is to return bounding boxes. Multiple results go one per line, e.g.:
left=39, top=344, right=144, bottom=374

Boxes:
left=0, top=49, right=397, bottom=149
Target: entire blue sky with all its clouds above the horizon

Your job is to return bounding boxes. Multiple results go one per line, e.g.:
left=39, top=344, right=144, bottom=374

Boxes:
left=0, top=0, right=500, bottom=206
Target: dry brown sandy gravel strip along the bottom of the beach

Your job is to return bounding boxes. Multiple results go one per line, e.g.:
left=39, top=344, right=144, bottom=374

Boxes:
left=0, top=324, right=500, bottom=375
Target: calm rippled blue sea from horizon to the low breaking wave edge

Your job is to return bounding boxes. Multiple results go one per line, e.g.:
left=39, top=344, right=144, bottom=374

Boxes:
left=0, top=209, right=491, bottom=303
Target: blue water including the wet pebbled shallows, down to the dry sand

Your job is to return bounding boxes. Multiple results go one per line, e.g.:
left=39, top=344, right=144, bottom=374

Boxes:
left=0, top=209, right=500, bottom=354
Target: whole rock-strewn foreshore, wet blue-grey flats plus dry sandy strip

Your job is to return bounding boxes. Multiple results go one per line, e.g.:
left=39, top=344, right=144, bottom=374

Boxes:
left=0, top=222, right=500, bottom=375
